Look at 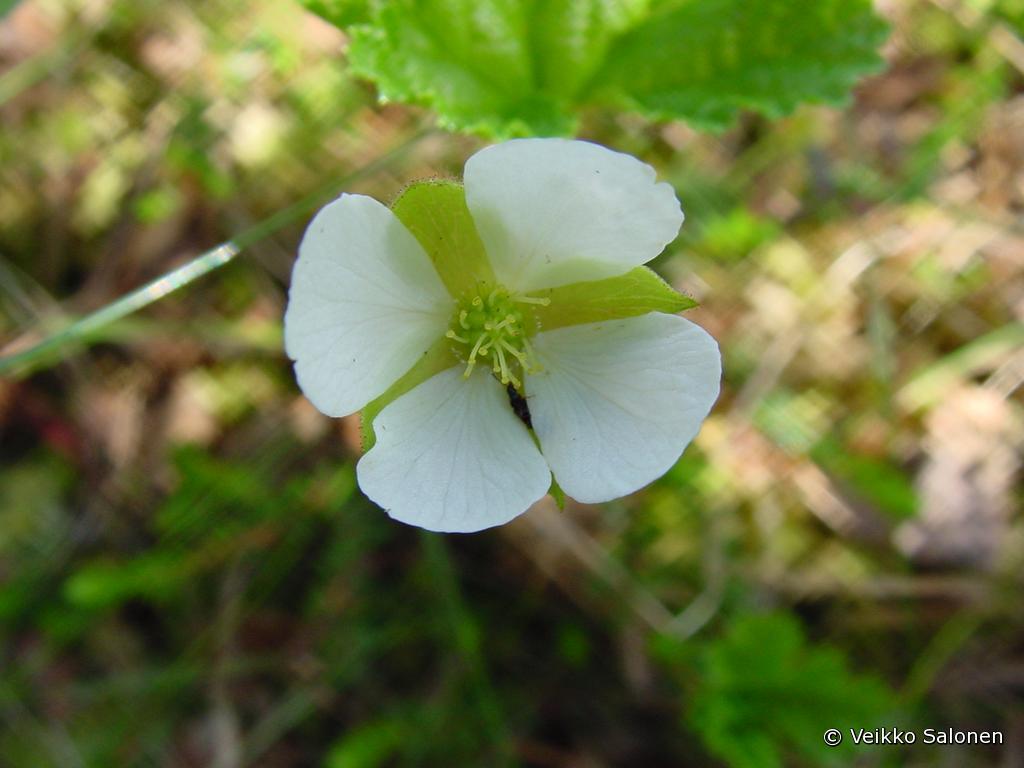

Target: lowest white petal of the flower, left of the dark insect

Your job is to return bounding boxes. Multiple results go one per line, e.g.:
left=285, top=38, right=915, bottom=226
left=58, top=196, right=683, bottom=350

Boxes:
left=356, top=368, right=551, bottom=532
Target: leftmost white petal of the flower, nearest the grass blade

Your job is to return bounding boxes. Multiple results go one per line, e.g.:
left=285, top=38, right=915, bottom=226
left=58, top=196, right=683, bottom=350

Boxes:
left=285, top=195, right=453, bottom=416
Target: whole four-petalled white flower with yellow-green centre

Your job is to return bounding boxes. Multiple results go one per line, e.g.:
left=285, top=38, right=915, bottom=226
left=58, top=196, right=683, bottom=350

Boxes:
left=285, top=139, right=721, bottom=531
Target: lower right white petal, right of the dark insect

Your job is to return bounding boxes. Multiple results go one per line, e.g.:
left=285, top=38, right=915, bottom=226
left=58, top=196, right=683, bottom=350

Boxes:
left=525, top=312, right=722, bottom=503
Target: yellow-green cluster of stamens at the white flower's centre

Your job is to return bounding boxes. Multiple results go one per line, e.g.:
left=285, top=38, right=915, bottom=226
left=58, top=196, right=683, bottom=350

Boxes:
left=445, top=287, right=551, bottom=389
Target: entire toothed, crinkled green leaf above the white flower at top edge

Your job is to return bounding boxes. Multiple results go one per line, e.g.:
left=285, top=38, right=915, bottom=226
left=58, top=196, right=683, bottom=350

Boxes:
left=321, top=0, right=886, bottom=138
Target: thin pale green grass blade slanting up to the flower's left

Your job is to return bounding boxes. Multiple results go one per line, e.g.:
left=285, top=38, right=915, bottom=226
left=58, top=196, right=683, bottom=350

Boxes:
left=0, top=128, right=432, bottom=376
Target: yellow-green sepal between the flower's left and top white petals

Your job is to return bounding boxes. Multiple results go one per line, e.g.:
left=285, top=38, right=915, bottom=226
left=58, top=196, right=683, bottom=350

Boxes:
left=391, top=179, right=496, bottom=298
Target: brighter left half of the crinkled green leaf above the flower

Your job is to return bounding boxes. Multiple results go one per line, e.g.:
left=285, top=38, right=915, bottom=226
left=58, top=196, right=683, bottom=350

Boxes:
left=349, top=0, right=649, bottom=138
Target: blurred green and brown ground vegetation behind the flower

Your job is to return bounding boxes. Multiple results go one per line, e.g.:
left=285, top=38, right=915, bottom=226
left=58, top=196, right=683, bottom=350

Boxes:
left=0, top=0, right=1024, bottom=768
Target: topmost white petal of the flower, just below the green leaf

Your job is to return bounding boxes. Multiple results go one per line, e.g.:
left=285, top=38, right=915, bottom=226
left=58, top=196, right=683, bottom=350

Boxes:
left=464, top=138, right=683, bottom=291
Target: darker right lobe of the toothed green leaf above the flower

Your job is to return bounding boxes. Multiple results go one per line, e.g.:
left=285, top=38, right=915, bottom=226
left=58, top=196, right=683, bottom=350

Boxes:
left=593, top=0, right=887, bottom=130
